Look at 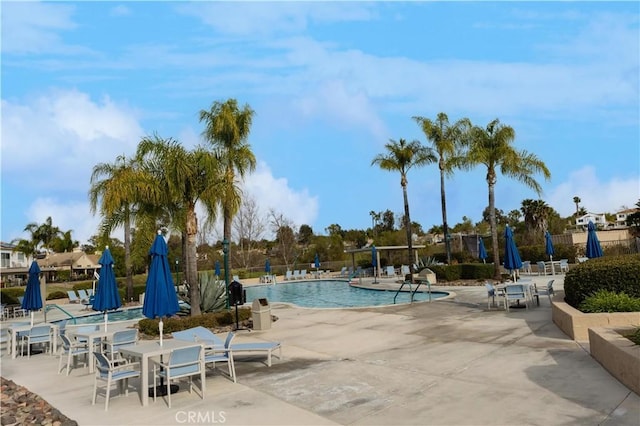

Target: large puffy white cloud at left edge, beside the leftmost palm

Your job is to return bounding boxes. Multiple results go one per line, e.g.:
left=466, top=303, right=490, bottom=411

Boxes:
left=1, top=91, right=143, bottom=190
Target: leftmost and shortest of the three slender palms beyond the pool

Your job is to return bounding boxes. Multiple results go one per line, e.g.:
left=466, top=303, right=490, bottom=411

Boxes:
left=371, top=139, right=437, bottom=282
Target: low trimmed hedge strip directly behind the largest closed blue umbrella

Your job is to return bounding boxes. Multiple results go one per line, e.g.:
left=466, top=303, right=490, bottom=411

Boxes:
left=138, top=308, right=251, bottom=336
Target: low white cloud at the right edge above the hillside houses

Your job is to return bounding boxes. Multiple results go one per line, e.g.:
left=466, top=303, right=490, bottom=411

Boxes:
left=545, top=166, right=640, bottom=216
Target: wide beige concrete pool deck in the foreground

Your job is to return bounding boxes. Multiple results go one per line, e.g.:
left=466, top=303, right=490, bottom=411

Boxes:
left=2, top=277, right=640, bottom=426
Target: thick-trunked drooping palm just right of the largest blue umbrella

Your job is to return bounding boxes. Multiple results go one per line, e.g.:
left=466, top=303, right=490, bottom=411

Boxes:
left=136, top=136, right=226, bottom=316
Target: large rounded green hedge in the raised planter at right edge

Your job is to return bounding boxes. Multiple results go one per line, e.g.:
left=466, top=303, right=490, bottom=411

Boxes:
left=564, top=254, right=640, bottom=309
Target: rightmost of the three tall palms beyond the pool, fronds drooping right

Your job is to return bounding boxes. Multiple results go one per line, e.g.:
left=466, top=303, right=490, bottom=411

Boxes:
left=461, top=118, right=551, bottom=279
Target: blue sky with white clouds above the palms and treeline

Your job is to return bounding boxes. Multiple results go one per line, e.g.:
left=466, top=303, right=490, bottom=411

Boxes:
left=0, top=1, right=640, bottom=242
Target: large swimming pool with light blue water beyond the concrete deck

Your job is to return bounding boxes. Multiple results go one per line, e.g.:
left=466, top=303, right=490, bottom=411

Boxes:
left=245, top=280, right=449, bottom=308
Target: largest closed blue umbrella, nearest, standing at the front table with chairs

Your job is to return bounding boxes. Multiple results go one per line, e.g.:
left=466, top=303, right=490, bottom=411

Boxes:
left=142, top=233, right=180, bottom=346
